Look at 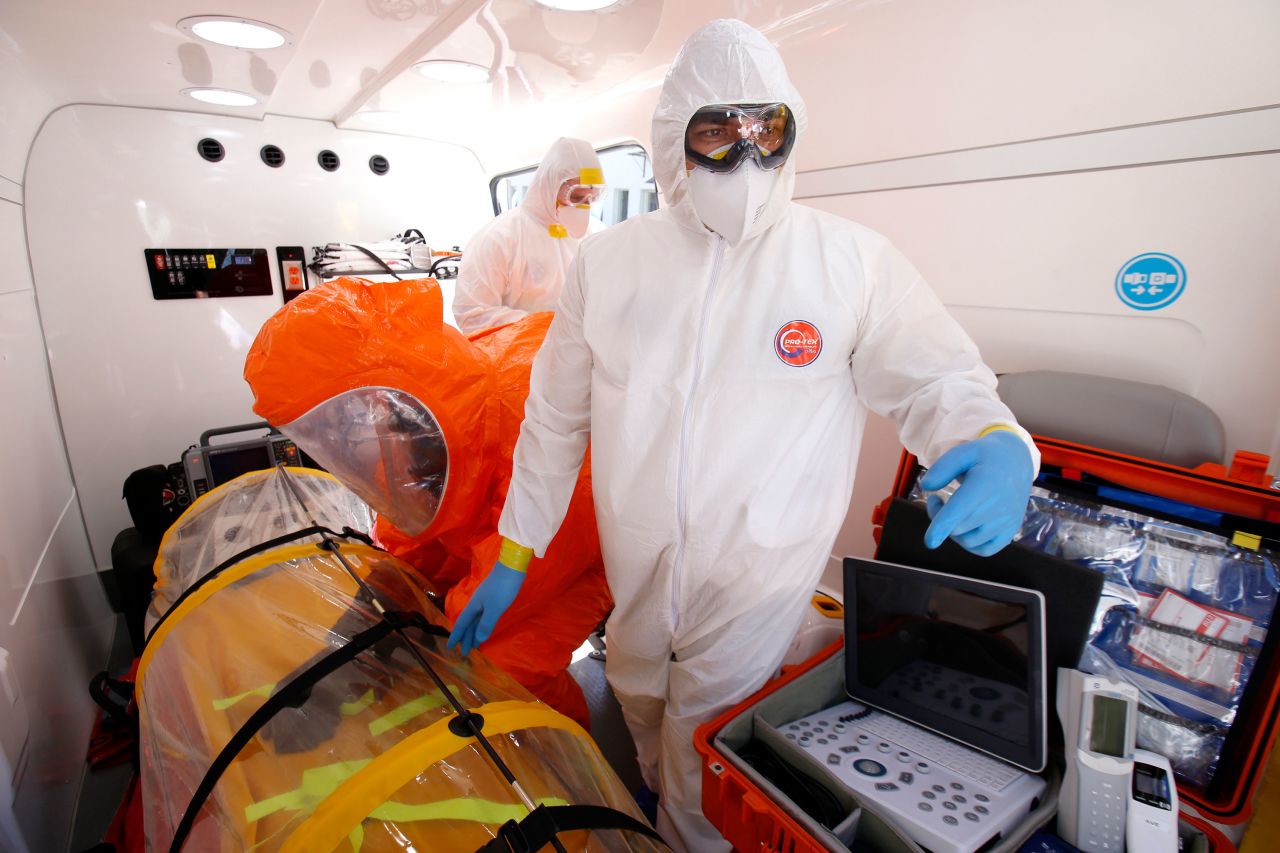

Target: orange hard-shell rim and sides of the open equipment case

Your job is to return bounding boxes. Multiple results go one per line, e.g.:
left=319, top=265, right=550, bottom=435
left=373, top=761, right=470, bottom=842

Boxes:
left=694, top=435, right=1280, bottom=853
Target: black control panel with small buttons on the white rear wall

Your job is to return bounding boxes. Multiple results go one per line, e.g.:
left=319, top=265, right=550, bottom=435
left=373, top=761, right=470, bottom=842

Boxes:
left=143, top=248, right=271, bottom=300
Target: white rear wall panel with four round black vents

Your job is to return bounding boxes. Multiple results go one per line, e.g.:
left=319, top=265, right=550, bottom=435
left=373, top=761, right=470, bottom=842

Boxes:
left=26, top=105, right=493, bottom=565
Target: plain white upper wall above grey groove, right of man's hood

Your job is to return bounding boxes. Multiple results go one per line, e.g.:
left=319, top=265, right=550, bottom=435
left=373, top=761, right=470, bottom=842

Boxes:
left=773, top=0, right=1280, bottom=169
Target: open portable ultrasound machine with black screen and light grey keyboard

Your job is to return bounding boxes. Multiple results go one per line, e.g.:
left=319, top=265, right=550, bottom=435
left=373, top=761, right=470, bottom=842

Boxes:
left=778, top=558, right=1048, bottom=853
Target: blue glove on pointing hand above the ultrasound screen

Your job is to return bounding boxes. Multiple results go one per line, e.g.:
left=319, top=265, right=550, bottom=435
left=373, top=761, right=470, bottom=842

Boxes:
left=920, top=429, right=1036, bottom=557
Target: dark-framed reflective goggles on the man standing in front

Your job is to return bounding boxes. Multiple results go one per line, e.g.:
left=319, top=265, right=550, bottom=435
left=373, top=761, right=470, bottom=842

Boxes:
left=685, top=104, right=796, bottom=172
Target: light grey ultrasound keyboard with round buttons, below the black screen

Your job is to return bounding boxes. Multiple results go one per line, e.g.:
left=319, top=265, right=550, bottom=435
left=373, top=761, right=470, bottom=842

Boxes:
left=778, top=702, right=1044, bottom=853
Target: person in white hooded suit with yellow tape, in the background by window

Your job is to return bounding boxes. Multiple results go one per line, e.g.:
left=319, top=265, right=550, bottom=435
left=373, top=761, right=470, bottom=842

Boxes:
left=453, top=137, right=604, bottom=334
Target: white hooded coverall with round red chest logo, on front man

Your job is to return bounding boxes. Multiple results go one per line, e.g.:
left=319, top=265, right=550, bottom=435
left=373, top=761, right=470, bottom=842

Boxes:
left=499, top=20, right=1039, bottom=853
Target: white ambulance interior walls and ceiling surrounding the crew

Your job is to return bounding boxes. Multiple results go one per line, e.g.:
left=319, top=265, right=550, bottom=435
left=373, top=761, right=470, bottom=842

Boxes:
left=0, top=0, right=1280, bottom=853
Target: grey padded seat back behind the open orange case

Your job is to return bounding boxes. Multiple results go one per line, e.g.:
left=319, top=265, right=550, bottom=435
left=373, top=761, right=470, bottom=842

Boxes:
left=1000, top=370, right=1226, bottom=467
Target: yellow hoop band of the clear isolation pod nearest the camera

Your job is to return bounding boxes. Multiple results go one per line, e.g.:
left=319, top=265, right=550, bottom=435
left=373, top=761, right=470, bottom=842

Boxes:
left=280, top=701, right=591, bottom=853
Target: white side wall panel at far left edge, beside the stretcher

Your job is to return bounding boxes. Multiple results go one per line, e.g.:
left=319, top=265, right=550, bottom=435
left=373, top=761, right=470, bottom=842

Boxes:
left=0, top=192, right=114, bottom=850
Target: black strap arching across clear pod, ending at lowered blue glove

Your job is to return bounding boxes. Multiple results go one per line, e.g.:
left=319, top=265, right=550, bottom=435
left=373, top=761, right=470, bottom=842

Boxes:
left=169, top=611, right=449, bottom=853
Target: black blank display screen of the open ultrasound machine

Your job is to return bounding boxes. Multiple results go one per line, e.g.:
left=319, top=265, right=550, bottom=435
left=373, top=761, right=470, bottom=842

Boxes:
left=845, top=560, right=1046, bottom=771
